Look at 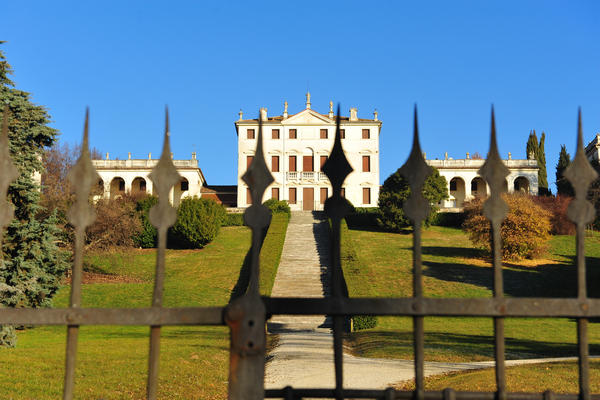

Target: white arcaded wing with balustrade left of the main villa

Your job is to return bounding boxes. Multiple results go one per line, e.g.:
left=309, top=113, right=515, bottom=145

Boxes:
left=92, top=153, right=206, bottom=207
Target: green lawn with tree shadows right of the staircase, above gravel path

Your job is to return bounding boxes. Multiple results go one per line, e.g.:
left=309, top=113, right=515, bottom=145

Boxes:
left=342, top=223, right=600, bottom=361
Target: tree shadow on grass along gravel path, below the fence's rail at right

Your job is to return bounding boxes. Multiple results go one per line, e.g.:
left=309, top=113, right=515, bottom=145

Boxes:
left=349, top=330, right=600, bottom=360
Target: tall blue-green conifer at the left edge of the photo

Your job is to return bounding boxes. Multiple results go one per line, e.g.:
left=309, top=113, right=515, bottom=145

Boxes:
left=0, top=42, right=67, bottom=346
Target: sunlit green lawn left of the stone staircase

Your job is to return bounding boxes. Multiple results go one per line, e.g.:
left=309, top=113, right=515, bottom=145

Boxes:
left=0, top=215, right=287, bottom=399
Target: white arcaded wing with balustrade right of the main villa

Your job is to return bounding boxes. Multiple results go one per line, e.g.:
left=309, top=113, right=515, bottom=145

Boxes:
left=426, top=153, right=539, bottom=210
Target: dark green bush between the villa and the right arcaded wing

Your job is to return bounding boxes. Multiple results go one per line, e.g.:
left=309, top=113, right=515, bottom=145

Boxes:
left=377, top=168, right=448, bottom=232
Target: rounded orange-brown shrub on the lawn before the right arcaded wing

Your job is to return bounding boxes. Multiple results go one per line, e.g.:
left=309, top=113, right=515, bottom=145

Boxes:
left=463, top=193, right=552, bottom=259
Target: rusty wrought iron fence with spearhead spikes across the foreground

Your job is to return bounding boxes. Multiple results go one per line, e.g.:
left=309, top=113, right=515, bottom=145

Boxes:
left=0, top=107, right=600, bottom=400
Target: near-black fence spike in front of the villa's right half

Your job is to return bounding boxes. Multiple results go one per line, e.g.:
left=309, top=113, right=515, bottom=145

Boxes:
left=321, top=103, right=354, bottom=219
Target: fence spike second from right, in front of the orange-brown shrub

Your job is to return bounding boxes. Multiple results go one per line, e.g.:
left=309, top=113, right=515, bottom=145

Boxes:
left=479, top=106, right=509, bottom=225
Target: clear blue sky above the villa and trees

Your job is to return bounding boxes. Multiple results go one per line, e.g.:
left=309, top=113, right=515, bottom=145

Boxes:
left=0, top=0, right=600, bottom=191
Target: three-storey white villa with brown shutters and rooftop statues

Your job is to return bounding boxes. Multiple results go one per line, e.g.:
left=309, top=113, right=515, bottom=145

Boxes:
left=235, top=93, right=381, bottom=210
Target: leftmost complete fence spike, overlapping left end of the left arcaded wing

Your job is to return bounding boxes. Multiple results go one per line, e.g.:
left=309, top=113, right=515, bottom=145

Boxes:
left=67, top=108, right=100, bottom=229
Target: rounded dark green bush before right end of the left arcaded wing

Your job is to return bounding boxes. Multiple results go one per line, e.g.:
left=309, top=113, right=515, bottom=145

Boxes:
left=169, top=197, right=225, bottom=249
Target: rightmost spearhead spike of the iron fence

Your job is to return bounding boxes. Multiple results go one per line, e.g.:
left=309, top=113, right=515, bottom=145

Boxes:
left=564, top=108, right=598, bottom=225
